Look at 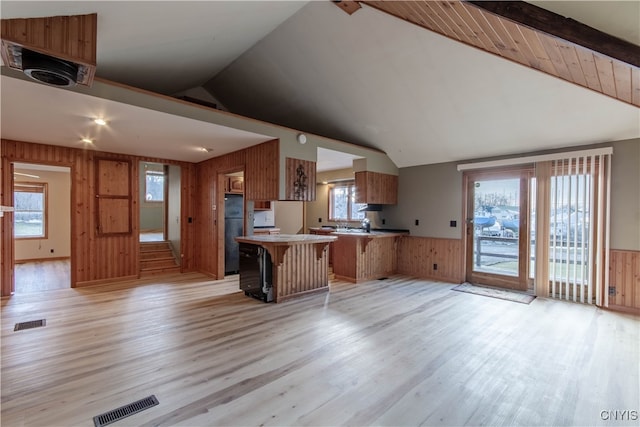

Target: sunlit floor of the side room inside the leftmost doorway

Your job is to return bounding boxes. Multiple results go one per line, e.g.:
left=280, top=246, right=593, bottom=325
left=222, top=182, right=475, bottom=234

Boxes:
left=14, top=259, right=71, bottom=294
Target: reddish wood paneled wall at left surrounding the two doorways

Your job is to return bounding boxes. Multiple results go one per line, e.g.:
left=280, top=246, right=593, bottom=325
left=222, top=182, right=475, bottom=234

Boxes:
left=0, top=140, right=194, bottom=295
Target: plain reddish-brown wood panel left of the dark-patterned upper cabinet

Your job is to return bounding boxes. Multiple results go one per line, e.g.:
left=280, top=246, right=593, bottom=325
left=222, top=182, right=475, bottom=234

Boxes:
left=244, top=139, right=280, bottom=200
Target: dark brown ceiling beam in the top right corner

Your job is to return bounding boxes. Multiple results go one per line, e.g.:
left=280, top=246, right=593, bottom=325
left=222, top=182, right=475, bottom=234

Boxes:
left=465, top=0, right=640, bottom=67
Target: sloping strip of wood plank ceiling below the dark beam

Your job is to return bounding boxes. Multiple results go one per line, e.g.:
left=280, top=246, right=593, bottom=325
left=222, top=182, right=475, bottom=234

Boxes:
left=360, top=0, right=640, bottom=107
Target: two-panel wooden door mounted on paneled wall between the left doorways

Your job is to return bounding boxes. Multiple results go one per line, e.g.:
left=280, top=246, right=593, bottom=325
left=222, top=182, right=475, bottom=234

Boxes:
left=95, top=158, right=132, bottom=236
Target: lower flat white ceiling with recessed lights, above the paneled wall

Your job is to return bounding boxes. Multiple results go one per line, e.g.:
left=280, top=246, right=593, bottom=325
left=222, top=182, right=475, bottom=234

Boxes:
left=0, top=75, right=273, bottom=163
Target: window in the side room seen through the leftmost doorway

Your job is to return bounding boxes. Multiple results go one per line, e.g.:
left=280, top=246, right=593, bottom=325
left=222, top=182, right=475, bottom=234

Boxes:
left=13, top=182, right=47, bottom=239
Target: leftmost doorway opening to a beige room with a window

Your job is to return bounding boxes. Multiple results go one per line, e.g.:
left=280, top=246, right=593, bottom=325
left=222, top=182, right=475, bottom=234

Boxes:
left=13, top=163, right=71, bottom=294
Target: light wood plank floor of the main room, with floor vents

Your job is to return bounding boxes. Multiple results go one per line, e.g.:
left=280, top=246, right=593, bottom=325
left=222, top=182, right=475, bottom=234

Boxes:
left=1, top=274, right=640, bottom=426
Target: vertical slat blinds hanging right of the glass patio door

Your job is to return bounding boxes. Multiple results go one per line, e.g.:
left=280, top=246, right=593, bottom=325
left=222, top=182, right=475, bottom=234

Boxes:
left=536, top=154, right=611, bottom=307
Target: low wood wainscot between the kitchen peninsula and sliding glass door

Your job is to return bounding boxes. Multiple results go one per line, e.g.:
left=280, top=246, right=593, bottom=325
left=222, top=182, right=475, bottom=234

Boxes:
left=398, top=236, right=465, bottom=283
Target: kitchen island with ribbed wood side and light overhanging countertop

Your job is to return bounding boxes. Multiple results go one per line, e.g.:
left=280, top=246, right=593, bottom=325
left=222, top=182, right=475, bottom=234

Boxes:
left=236, top=234, right=337, bottom=303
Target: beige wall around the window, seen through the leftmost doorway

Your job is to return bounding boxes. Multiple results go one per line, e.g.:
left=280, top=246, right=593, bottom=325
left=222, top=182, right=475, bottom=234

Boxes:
left=15, top=168, right=71, bottom=261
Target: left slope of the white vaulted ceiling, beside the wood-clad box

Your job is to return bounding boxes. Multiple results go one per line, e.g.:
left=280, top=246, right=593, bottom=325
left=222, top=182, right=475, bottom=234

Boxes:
left=0, top=0, right=307, bottom=95
